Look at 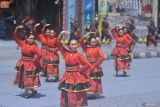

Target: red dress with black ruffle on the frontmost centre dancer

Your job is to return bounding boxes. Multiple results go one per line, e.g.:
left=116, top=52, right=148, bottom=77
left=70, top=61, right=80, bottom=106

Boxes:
left=58, top=43, right=90, bottom=107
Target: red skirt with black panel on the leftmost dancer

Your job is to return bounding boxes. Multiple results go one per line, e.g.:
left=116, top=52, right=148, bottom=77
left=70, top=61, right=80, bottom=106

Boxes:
left=14, top=60, right=40, bottom=89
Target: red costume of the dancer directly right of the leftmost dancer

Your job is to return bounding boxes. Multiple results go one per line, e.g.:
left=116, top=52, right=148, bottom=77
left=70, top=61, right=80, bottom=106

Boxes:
left=38, top=34, right=59, bottom=77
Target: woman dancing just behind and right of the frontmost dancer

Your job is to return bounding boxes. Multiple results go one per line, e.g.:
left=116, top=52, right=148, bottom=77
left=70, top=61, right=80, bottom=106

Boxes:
left=80, top=32, right=105, bottom=98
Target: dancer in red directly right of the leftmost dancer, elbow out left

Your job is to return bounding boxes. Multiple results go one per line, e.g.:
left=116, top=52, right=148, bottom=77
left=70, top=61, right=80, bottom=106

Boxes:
left=37, top=25, right=59, bottom=82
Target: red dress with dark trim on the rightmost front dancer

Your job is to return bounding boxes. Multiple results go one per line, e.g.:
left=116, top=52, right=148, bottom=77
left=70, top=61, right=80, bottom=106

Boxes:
left=111, top=29, right=132, bottom=71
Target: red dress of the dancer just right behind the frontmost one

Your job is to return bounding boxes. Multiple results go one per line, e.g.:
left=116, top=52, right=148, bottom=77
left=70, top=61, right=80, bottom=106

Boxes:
left=80, top=37, right=105, bottom=94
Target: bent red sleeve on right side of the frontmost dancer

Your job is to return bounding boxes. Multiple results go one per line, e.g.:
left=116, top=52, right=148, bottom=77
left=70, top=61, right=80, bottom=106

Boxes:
left=78, top=54, right=90, bottom=72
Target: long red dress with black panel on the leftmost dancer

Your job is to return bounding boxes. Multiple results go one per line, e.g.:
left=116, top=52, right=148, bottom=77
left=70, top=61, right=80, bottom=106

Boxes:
left=13, top=32, right=41, bottom=89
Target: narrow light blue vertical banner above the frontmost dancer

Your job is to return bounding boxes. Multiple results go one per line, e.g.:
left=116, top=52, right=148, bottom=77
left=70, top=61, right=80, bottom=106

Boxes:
left=68, top=0, right=75, bottom=31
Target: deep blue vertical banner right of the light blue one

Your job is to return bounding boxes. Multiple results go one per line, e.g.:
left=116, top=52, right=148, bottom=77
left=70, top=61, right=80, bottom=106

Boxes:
left=84, top=0, right=94, bottom=32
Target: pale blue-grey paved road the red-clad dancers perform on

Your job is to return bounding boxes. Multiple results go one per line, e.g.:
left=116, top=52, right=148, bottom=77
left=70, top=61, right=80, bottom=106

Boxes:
left=0, top=41, right=160, bottom=107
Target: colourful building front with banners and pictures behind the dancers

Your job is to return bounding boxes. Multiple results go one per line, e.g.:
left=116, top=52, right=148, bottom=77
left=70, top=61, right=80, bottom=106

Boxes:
left=63, top=0, right=160, bottom=33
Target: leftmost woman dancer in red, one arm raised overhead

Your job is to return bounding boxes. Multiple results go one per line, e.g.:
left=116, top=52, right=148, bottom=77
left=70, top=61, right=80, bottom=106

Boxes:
left=13, top=25, right=41, bottom=98
